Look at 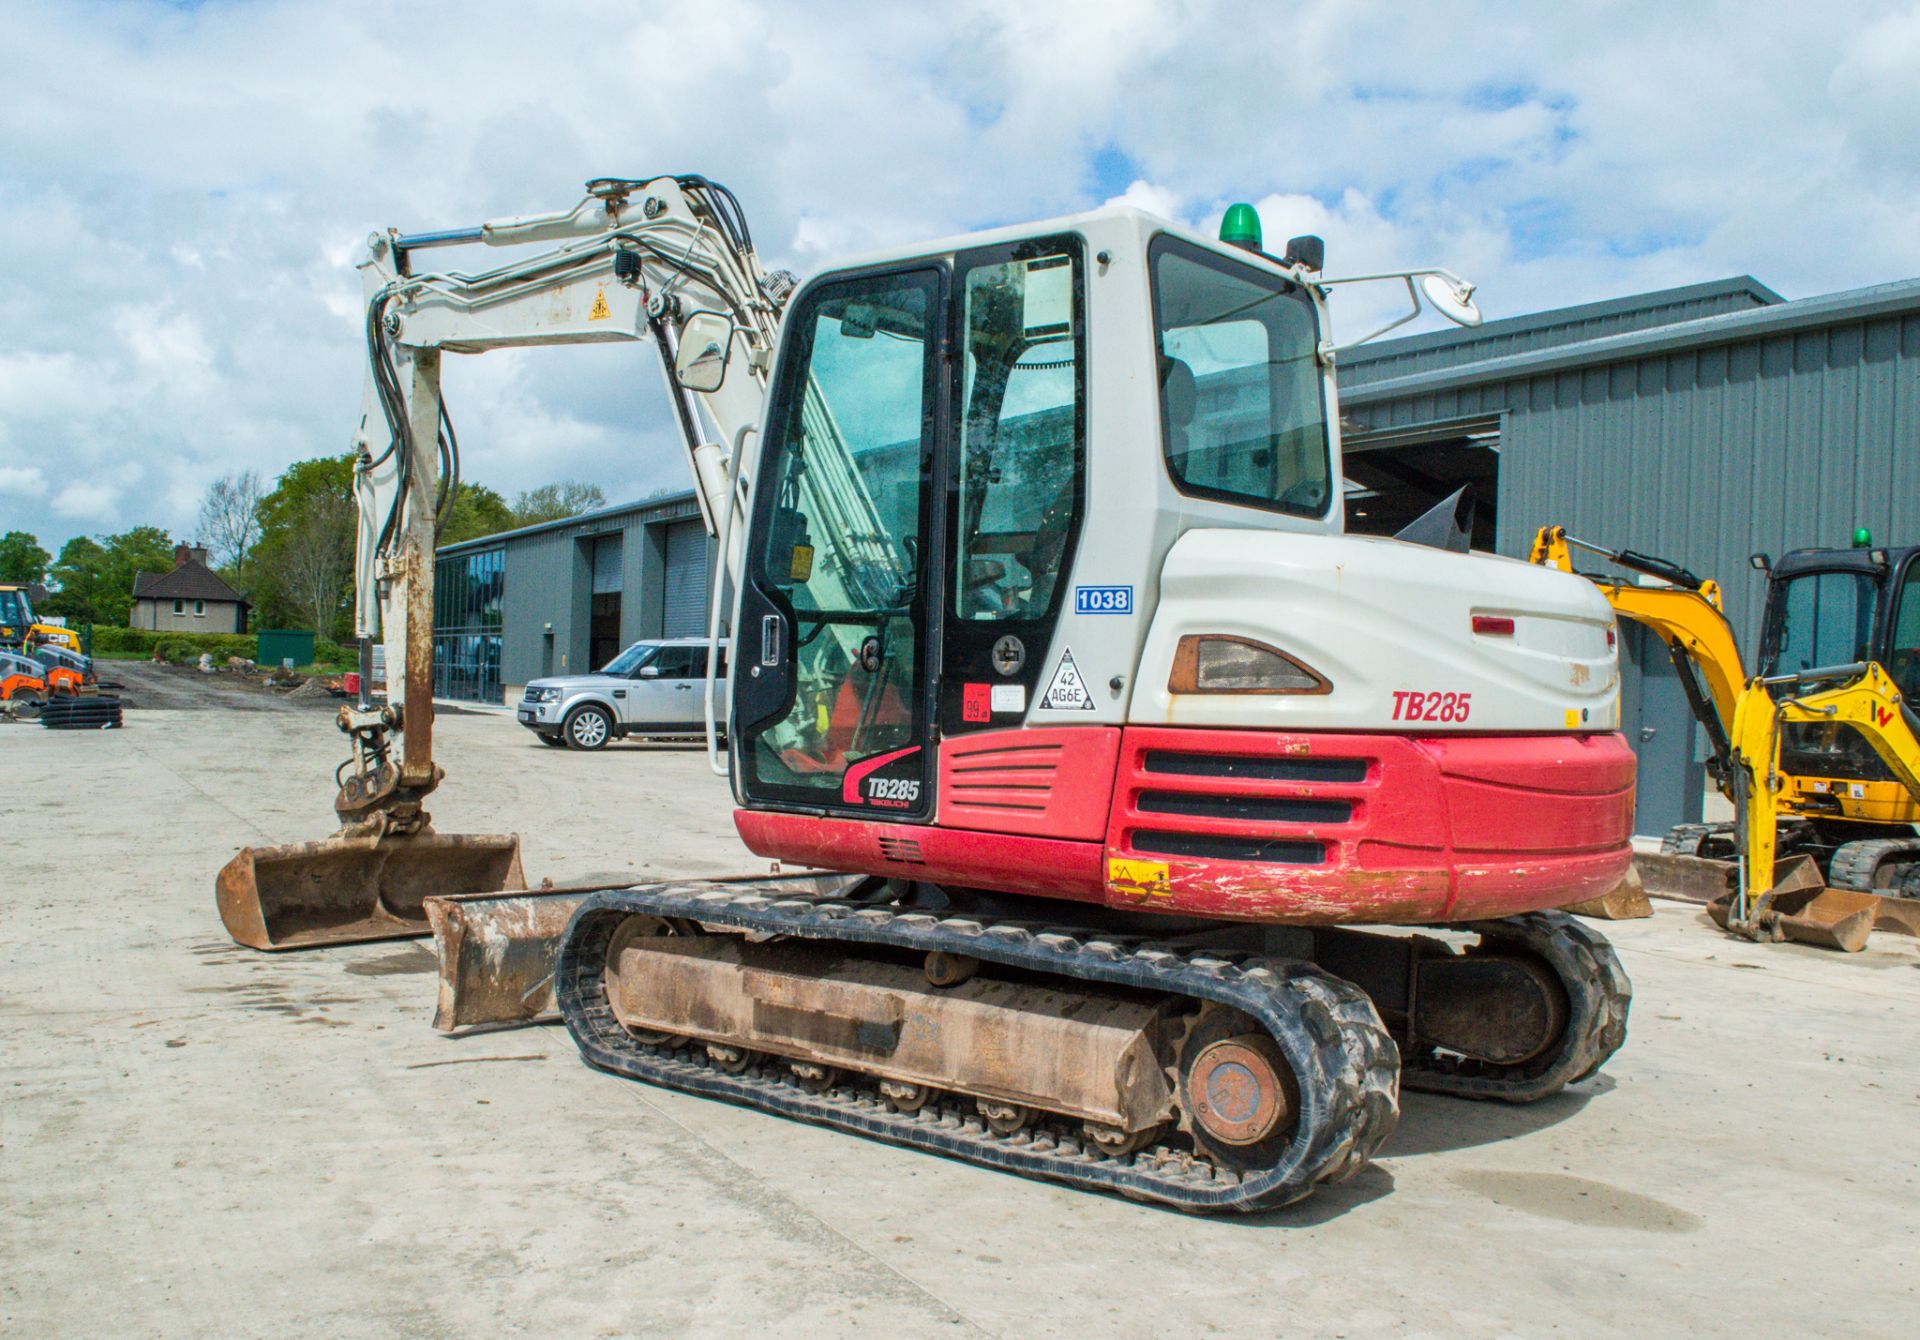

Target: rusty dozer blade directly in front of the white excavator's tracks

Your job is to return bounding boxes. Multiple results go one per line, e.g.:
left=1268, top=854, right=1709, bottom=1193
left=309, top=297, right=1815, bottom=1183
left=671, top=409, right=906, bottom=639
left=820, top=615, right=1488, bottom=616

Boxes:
left=426, top=870, right=862, bottom=1033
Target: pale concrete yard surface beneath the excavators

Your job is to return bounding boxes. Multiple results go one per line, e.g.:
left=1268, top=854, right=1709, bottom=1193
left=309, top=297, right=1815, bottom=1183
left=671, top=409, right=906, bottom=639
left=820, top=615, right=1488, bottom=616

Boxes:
left=0, top=668, right=1920, bottom=1340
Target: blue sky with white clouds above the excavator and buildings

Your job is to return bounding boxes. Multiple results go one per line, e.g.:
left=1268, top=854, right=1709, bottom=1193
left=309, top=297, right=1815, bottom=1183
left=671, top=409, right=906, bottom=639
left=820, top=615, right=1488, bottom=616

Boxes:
left=0, top=0, right=1920, bottom=549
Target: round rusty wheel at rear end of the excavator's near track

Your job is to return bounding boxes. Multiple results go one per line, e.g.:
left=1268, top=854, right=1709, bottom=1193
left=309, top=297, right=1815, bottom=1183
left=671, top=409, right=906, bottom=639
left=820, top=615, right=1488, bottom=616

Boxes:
left=1181, top=1010, right=1300, bottom=1169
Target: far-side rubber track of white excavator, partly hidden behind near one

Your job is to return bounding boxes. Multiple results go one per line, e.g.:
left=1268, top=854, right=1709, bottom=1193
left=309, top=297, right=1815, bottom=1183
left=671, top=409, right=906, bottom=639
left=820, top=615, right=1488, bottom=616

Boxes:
left=1400, top=912, right=1634, bottom=1102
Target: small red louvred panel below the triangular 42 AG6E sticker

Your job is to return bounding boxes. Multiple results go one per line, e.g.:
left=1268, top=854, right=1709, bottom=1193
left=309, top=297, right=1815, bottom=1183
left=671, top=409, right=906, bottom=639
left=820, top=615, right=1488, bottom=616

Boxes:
left=933, top=726, right=1119, bottom=843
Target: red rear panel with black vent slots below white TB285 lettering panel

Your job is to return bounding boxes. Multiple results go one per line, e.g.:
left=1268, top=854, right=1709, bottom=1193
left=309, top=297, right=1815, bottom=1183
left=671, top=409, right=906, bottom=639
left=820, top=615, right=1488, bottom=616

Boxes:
left=1106, top=726, right=1634, bottom=925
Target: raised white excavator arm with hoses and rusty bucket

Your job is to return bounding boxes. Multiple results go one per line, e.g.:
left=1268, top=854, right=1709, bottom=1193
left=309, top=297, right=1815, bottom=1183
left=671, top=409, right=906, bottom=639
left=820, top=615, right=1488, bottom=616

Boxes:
left=217, top=177, right=794, bottom=948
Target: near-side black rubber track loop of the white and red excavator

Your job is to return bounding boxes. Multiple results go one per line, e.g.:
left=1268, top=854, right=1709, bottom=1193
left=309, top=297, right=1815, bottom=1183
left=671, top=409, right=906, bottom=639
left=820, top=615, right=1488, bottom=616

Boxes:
left=555, top=883, right=1400, bottom=1213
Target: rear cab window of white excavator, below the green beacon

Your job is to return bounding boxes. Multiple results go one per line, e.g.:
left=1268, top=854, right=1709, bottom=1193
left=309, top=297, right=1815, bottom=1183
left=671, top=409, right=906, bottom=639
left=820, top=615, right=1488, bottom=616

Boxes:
left=1148, top=236, right=1332, bottom=516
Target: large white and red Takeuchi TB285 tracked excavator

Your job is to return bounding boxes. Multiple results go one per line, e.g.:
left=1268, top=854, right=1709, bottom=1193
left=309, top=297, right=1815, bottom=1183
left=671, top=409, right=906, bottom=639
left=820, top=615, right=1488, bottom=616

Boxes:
left=223, top=177, right=1634, bottom=1211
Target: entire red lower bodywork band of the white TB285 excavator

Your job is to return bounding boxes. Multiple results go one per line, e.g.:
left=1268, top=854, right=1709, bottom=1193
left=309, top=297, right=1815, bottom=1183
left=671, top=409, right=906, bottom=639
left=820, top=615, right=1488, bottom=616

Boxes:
left=733, top=726, right=1634, bottom=925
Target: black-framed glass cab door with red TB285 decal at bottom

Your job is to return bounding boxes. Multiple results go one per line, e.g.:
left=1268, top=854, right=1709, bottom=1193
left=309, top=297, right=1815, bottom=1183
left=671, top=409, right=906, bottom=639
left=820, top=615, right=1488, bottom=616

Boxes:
left=730, top=265, right=945, bottom=820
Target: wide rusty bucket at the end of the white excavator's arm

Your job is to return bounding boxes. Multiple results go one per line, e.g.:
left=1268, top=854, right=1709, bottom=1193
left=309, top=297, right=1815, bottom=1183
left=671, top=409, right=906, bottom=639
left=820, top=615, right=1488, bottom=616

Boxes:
left=215, top=833, right=526, bottom=950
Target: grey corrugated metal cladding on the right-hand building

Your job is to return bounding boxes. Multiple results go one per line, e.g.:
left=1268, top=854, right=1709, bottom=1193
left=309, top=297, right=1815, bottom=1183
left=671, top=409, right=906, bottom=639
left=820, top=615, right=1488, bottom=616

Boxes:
left=1340, top=280, right=1920, bottom=647
